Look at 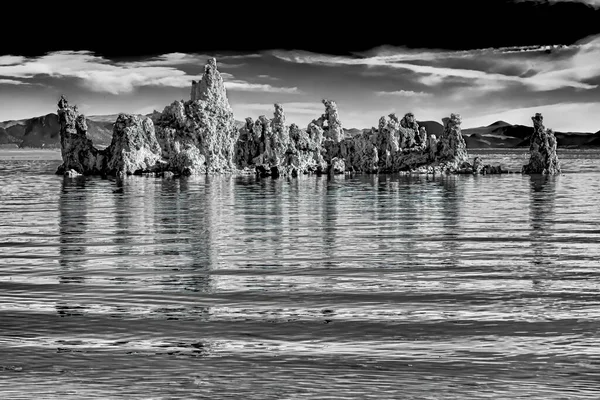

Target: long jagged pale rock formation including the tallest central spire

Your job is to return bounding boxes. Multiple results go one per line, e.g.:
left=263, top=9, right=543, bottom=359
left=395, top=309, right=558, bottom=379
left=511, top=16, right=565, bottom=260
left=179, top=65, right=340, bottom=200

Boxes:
left=59, top=59, right=524, bottom=177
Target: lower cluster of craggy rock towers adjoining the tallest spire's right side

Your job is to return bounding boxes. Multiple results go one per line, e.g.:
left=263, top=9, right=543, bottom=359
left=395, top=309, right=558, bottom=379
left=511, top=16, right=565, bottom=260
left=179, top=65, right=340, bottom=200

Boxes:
left=236, top=104, right=476, bottom=175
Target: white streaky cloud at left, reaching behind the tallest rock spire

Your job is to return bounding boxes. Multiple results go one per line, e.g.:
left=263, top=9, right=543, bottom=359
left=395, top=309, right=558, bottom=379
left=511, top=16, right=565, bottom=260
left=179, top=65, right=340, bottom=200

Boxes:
left=0, top=51, right=300, bottom=95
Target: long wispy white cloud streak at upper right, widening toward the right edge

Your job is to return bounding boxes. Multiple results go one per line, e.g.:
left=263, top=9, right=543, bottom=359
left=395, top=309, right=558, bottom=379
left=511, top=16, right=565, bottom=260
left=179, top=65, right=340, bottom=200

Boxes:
left=271, top=34, right=600, bottom=91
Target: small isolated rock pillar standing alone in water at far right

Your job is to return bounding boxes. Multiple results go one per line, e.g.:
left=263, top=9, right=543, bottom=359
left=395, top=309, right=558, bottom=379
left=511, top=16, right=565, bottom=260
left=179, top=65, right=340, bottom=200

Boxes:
left=522, top=113, right=561, bottom=175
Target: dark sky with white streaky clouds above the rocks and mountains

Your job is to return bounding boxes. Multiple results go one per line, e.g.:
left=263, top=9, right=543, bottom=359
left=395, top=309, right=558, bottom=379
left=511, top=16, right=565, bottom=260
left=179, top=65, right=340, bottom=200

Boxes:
left=0, top=0, right=600, bottom=132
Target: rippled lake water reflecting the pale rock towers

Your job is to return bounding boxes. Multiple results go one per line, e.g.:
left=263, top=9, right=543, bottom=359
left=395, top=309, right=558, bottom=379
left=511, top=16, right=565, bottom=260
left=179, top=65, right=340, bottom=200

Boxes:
left=0, top=150, right=600, bottom=399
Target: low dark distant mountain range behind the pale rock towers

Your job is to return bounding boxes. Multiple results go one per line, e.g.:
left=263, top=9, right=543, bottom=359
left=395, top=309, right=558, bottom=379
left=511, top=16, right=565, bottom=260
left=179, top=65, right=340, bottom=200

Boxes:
left=0, top=113, right=600, bottom=149
